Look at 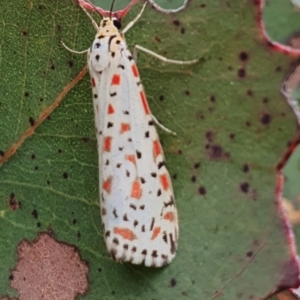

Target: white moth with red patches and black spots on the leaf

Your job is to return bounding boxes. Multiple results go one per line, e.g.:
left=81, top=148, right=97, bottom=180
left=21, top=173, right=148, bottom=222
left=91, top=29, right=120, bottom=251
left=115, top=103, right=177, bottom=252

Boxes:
left=63, top=2, right=198, bottom=267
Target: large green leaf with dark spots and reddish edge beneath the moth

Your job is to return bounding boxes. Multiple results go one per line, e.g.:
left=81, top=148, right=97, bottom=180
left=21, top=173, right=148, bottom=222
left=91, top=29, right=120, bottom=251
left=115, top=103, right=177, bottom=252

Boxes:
left=0, top=0, right=298, bottom=300
